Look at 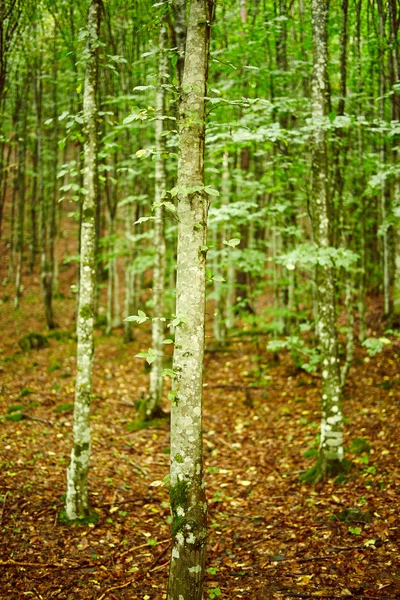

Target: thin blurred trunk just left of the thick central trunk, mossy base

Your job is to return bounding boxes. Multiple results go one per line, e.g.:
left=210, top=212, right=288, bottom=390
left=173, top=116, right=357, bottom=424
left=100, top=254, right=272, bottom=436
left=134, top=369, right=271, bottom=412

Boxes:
left=143, top=23, right=168, bottom=420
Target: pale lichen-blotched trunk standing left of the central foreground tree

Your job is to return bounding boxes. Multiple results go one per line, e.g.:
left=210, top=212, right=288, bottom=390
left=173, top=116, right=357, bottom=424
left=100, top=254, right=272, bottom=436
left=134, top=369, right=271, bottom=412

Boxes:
left=65, top=0, right=101, bottom=520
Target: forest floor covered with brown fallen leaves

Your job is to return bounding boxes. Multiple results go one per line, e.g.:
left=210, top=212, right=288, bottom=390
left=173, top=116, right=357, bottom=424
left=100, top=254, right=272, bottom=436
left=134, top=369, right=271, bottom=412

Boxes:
left=0, top=246, right=400, bottom=600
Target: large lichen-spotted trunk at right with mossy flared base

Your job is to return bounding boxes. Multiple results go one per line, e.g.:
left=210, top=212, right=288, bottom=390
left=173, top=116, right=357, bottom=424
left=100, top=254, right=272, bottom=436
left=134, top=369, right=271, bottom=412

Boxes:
left=311, top=0, right=343, bottom=477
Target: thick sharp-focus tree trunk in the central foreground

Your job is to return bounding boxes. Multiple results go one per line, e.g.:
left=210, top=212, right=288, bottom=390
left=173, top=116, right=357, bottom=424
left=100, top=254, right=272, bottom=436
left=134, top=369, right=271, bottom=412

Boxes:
left=168, top=0, right=214, bottom=600
